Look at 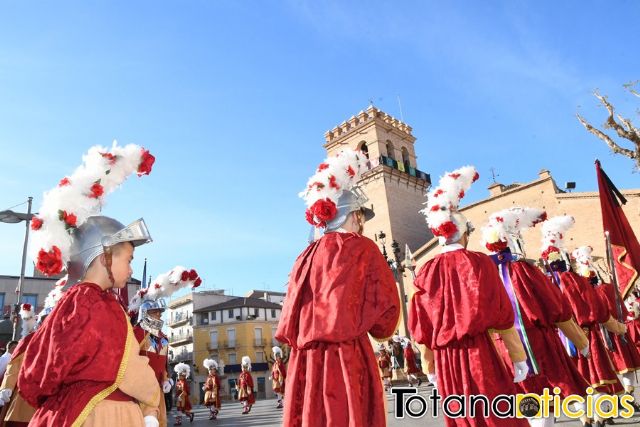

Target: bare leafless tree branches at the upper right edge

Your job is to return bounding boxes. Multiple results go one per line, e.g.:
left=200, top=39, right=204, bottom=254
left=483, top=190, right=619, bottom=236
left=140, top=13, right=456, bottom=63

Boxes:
left=576, top=80, right=640, bottom=170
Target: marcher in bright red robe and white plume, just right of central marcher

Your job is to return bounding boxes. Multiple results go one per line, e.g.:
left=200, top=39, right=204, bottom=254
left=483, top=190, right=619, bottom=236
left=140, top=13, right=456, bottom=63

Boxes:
left=409, top=166, right=528, bottom=427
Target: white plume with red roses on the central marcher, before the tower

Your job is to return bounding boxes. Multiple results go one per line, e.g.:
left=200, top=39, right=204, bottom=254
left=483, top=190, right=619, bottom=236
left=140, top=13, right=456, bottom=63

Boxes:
left=299, top=149, right=369, bottom=227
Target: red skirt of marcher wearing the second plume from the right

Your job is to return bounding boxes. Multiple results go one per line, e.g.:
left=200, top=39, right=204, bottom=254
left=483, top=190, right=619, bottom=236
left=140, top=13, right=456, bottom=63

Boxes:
left=574, top=325, right=620, bottom=393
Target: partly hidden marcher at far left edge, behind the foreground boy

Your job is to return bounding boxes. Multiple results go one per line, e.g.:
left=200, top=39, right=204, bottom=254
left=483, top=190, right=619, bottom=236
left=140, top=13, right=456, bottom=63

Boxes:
left=0, top=276, right=67, bottom=427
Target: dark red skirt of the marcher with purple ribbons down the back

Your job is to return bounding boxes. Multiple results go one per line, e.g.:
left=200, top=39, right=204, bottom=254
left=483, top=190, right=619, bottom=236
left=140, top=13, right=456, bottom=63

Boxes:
left=498, top=327, right=589, bottom=398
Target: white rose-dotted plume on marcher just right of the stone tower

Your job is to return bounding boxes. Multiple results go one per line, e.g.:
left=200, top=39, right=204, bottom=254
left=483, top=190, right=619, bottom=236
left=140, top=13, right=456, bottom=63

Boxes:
left=420, top=166, right=480, bottom=242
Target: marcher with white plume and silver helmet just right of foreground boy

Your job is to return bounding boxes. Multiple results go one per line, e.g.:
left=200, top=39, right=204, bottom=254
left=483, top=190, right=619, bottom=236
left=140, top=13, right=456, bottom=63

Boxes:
left=129, top=266, right=202, bottom=427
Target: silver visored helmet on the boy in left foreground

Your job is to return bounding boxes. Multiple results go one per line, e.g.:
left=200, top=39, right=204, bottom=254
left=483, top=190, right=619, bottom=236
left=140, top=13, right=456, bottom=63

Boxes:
left=66, top=216, right=152, bottom=286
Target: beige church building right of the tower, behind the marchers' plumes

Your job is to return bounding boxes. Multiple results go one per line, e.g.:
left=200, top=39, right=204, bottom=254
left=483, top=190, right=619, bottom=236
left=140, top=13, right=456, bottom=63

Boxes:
left=414, top=169, right=640, bottom=286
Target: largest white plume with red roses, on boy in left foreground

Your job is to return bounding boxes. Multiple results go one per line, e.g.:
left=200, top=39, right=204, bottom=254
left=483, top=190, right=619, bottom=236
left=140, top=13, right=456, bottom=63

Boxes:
left=31, top=141, right=155, bottom=276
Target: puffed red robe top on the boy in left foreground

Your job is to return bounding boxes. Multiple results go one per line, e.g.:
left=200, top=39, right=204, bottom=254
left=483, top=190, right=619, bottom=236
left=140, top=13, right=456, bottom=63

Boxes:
left=18, top=282, right=132, bottom=427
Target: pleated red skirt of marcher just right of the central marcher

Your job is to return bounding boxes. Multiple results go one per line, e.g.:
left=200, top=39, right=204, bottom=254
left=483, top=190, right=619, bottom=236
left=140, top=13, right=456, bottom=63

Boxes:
left=434, top=332, right=529, bottom=427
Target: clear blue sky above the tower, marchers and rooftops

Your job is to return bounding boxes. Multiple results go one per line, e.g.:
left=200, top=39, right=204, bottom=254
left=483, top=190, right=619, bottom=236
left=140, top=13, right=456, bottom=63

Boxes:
left=0, top=0, right=640, bottom=294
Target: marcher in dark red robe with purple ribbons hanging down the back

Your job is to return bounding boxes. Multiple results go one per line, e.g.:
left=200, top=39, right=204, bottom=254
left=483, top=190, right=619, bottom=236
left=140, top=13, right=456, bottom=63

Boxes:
left=482, top=207, right=589, bottom=426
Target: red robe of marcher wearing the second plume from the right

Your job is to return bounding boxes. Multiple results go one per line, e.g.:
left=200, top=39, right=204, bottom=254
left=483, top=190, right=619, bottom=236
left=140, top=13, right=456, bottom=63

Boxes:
left=560, top=271, right=621, bottom=393
